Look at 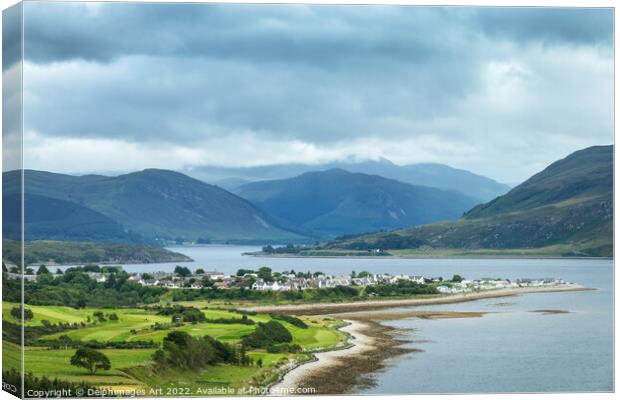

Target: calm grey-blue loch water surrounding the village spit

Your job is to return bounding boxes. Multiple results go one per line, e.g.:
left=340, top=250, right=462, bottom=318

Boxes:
left=118, top=246, right=613, bottom=394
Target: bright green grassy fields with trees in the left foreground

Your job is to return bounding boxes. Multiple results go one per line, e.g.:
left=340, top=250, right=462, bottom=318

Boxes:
left=2, top=303, right=346, bottom=395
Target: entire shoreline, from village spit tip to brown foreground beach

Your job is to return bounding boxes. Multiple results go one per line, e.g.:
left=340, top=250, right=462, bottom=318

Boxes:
left=266, top=286, right=596, bottom=396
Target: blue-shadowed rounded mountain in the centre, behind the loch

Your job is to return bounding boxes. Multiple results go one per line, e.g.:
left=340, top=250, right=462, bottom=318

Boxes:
left=235, top=169, right=476, bottom=236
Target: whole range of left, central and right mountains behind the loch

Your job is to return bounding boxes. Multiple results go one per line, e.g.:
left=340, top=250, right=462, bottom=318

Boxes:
left=3, top=146, right=613, bottom=256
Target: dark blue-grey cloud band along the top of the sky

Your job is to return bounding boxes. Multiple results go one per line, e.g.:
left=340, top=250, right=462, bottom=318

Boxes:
left=25, top=2, right=613, bottom=67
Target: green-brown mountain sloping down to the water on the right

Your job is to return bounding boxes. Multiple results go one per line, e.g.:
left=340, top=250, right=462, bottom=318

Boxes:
left=327, top=146, right=613, bottom=256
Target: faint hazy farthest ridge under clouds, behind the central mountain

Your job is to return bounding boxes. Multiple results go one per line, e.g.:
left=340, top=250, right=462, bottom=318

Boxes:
left=187, top=159, right=510, bottom=202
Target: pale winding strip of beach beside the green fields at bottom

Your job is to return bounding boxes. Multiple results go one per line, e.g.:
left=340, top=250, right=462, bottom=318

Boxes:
left=269, top=320, right=374, bottom=396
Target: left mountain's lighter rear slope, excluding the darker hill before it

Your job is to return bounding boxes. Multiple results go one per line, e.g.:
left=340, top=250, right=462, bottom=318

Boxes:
left=4, top=169, right=300, bottom=241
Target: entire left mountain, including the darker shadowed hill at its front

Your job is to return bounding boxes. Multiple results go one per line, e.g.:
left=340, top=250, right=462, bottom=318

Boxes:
left=4, top=169, right=302, bottom=241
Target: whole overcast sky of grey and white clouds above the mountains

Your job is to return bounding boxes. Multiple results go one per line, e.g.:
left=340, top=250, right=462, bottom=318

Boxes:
left=3, top=2, right=613, bottom=183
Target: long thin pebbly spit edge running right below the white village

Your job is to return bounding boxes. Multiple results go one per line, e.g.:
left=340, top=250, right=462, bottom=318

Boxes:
left=246, top=285, right=596, bottom=315
